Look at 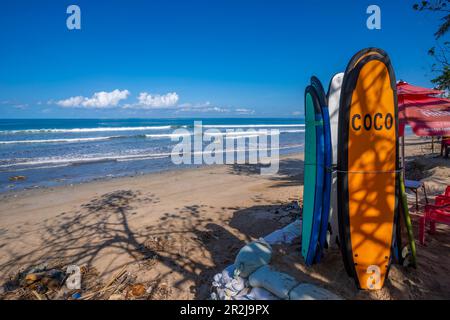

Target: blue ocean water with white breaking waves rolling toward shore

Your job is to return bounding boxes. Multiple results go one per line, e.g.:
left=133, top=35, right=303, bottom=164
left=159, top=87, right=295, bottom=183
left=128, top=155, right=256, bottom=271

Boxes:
left=0, top=119, right=305, bottom=192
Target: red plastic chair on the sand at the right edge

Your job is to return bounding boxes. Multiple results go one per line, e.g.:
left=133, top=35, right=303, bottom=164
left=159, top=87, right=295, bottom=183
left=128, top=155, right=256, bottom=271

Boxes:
left=419, top=186, right=450, bottom=245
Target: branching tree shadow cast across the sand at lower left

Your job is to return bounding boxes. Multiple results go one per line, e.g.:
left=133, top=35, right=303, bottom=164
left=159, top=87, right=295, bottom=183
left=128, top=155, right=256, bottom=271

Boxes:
left=0, top=190, right=250, bottom=299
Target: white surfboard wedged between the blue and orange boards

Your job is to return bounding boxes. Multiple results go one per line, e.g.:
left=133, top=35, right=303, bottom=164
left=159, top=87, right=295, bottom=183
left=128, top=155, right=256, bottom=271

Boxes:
left=327, top=72, right=344, bottom=247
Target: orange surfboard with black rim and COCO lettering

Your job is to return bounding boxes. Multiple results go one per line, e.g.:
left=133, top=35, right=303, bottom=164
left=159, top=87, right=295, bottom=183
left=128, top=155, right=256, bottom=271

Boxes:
left=338, top=48, right=399, bottom=290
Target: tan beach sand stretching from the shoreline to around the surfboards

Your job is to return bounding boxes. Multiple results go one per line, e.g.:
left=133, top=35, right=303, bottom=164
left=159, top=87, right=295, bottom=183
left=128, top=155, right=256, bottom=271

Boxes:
left=0, top=139, right=450, bottom=299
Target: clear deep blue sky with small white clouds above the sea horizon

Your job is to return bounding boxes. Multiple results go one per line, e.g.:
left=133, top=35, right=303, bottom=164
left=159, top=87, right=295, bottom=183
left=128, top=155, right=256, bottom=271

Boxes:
left=0, top=0, right=439, bottom=118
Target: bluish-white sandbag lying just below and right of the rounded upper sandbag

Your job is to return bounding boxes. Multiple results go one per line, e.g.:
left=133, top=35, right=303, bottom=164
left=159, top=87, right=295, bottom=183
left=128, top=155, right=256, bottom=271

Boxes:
left=249, top=266, right=298, bottom=299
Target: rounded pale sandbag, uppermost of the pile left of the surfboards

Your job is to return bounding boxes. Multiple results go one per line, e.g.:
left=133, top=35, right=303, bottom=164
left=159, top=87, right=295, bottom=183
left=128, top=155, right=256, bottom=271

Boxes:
left=234, top=239, right=272, bottom=278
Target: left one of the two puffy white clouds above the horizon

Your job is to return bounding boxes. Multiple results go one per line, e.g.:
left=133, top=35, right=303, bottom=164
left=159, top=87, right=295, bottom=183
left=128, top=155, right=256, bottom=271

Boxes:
left=56, top=89, right=130, bottom=108
